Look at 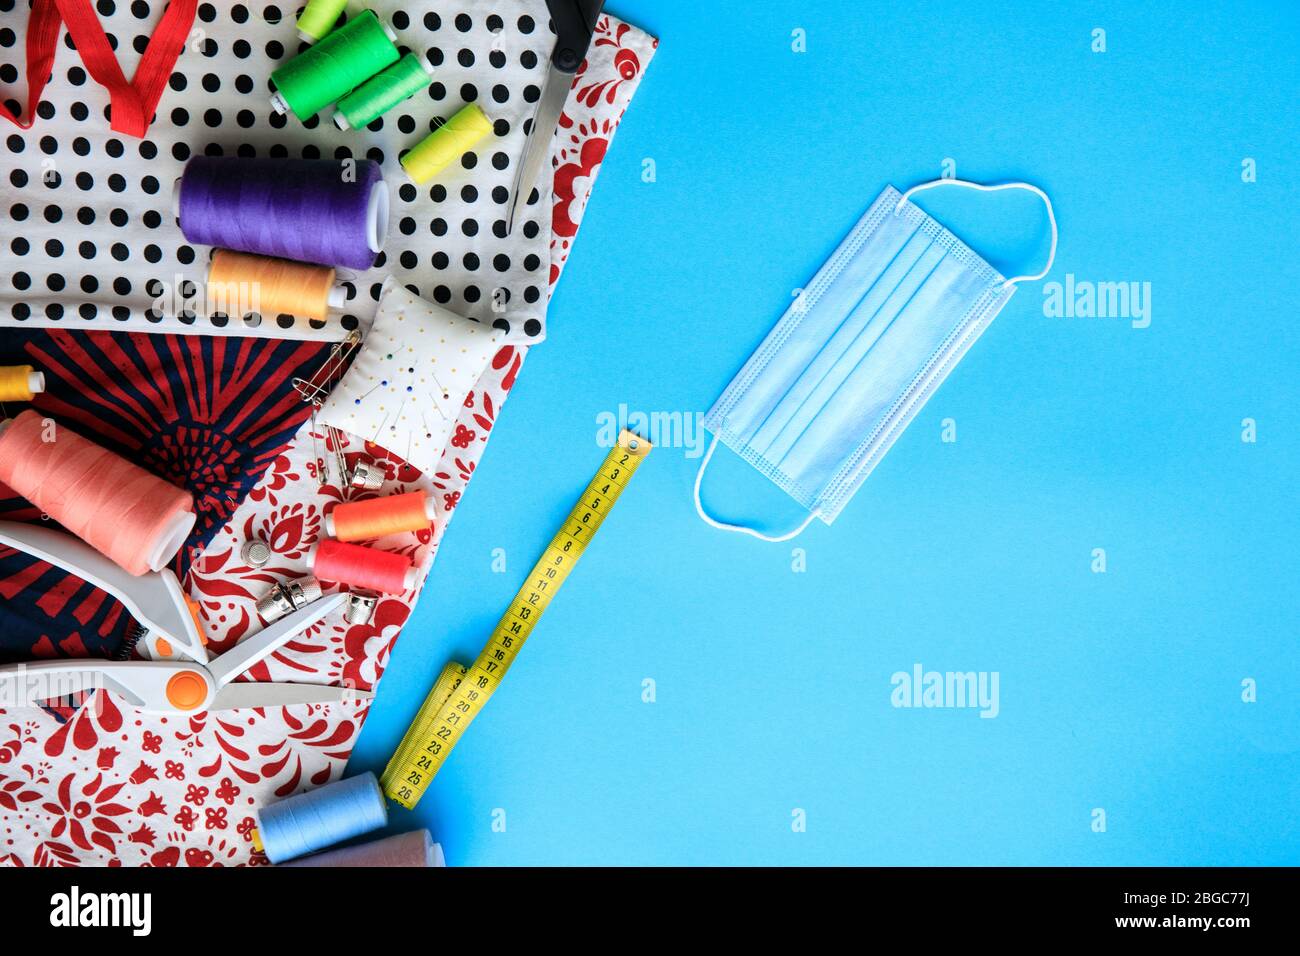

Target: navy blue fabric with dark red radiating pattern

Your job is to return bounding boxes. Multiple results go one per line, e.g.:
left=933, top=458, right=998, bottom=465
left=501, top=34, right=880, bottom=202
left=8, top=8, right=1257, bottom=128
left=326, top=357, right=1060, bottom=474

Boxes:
left=0, top=329, right=329, bottom=663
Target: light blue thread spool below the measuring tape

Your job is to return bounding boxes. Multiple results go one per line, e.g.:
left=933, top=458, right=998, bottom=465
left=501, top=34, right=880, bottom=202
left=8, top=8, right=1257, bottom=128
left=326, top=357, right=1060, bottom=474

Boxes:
left=257, top=773, right=389, bottom=864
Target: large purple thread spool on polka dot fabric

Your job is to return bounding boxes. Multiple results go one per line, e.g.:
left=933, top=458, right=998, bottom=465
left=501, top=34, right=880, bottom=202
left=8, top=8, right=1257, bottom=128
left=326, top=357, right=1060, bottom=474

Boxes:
left=174, top=156, right=389, bottom=271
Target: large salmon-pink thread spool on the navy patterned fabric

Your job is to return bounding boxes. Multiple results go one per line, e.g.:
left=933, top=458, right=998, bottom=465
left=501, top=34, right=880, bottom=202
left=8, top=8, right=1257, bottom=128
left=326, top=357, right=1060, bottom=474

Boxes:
left=0, top=408, right=195, bottom=575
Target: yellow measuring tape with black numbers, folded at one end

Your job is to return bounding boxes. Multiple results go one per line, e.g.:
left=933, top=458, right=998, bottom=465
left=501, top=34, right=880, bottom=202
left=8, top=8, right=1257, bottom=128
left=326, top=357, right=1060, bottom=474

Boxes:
left=380, top=429, right=653, bottom=810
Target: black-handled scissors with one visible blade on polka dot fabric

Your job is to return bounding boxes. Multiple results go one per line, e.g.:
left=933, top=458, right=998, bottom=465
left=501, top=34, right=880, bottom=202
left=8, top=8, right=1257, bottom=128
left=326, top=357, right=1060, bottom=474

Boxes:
left=507, top=0, right=605, bottom=232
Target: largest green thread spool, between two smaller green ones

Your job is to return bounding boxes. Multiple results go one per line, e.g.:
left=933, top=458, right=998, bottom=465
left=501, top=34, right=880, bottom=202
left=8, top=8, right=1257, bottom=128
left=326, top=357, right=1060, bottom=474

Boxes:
left=270, top=10, right=399, bottom=121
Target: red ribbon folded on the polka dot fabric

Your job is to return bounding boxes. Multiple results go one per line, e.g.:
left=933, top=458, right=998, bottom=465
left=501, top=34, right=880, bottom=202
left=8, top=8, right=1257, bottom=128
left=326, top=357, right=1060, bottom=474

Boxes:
left=0, top=0, right=198, bottom=137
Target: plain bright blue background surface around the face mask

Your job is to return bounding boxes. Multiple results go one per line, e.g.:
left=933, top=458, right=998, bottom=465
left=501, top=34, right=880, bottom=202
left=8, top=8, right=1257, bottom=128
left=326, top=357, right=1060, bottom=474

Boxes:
left=350, top=0, right=1300, bottom=865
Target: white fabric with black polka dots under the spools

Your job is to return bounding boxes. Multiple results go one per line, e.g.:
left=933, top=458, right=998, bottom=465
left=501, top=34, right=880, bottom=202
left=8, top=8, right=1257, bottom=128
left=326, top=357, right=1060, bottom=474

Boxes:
left=0, top=0, right=564, bottom=342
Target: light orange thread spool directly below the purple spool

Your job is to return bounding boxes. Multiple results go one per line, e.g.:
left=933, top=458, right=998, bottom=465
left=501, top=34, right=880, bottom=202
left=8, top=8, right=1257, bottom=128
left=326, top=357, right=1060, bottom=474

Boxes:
left=207, top=248, right=347, bottom=320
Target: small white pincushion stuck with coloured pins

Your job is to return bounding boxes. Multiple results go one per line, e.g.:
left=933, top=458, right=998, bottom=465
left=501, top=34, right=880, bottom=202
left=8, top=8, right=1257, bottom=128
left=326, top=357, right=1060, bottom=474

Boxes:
left=317, top=280, right=502, bottom=473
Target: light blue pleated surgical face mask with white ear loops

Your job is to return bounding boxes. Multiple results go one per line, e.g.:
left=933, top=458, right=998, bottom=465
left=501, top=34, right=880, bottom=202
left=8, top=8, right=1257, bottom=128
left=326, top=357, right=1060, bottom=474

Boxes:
left=696, top=179, right=1057, bottom=541
